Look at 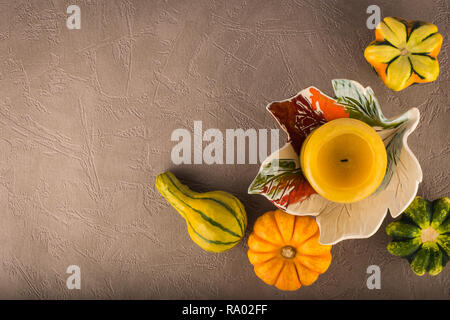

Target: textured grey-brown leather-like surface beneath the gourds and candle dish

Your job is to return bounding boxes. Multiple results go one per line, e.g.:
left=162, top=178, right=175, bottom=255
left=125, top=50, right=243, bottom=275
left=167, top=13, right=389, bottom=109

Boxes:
left=0, top=0, right=450, bottom=299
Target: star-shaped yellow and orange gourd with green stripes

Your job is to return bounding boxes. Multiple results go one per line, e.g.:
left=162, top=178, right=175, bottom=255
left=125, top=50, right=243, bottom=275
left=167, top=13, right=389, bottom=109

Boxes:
left=364, top=17, right=442, bottom=91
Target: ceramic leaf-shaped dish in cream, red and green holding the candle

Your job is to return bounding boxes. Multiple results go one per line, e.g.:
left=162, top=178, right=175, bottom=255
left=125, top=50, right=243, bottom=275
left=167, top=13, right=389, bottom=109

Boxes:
left=248, top=79, right=422, bottom=244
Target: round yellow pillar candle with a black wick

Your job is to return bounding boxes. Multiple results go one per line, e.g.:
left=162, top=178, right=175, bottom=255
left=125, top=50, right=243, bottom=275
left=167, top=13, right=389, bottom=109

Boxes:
left=300, top=118, right=387, bottom=203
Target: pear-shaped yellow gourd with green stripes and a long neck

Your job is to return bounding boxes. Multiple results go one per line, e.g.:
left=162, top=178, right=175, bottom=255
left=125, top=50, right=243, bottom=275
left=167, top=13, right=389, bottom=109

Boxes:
left=156, top=172, right=247, bottom=252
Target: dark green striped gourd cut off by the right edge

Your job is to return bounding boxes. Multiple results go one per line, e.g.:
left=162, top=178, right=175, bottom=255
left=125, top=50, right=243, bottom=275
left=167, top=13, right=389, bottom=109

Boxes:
left=386, top=197, right=450, bottom=276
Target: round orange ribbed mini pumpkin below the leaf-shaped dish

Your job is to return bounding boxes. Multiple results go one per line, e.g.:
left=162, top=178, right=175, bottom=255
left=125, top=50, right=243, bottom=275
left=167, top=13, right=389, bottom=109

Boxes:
left=248, top=210, right=331, bottom=291
